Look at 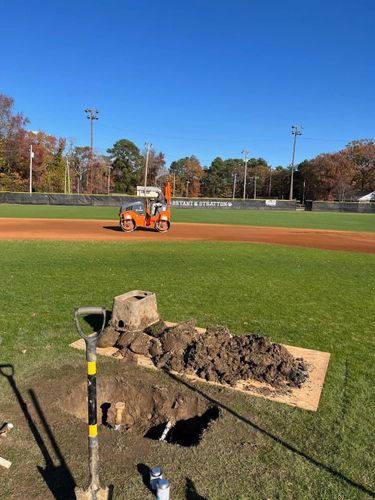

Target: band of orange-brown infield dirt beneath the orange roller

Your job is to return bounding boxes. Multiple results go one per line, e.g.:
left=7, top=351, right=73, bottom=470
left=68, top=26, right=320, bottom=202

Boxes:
left=0, top=218, right=375, bottom=253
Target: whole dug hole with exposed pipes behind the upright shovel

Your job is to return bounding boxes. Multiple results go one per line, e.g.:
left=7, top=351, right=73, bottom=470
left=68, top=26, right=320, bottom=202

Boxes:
left=59, top=376, right=220, bottom=446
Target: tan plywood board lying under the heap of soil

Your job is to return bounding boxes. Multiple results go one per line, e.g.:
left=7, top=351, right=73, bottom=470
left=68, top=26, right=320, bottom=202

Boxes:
left=70, top=322, right=330, bottom=411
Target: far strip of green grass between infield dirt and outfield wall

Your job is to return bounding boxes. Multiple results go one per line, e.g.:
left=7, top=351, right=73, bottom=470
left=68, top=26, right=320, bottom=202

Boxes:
left=0, top=205, right=375, bottom=232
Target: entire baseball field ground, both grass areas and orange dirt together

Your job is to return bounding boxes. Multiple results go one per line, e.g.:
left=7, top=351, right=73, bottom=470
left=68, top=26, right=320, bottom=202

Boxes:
left=0, top=205, right=375, bottom=500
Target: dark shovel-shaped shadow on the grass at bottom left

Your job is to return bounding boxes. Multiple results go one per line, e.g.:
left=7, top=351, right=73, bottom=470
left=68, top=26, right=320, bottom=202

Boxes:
left=0, top=364, right=76, bottom=500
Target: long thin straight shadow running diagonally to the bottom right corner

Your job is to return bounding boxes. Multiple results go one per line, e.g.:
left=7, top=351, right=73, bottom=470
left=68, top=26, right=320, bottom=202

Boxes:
left=164, top=370, right=375, bottom=498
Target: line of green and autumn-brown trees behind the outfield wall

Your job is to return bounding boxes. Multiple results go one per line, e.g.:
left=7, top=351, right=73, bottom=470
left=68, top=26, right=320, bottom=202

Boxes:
left=0, top=94, right=375, bottom=201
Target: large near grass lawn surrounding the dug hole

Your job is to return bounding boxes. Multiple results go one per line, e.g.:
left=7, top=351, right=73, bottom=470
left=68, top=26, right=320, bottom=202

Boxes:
left=0, top=240, right=375, bottom=500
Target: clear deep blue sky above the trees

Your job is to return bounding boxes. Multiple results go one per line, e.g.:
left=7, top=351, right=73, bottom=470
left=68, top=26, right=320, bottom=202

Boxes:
left=0, top=0, right=375, bottom=166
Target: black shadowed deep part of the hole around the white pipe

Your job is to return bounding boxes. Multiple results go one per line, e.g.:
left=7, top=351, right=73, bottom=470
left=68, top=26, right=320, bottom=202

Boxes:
left=145, top=406, right=220, bottom=446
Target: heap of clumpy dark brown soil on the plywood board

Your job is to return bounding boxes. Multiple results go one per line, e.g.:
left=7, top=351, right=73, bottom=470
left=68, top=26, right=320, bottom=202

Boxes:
left=118, top=320, right=308, bottom=387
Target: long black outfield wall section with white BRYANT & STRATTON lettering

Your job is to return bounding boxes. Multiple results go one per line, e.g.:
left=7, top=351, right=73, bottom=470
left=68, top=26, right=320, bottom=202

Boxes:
left=0, top=193, right=296, bottom=210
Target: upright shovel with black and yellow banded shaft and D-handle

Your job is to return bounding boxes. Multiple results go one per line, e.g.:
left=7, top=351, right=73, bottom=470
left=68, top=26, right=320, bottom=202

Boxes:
left=74, top=307, right=111, bottom=500
